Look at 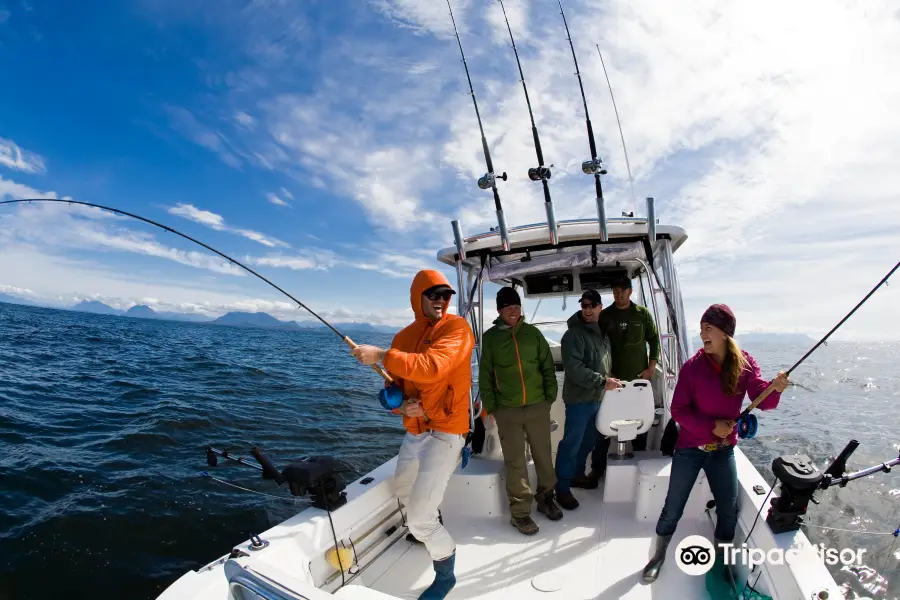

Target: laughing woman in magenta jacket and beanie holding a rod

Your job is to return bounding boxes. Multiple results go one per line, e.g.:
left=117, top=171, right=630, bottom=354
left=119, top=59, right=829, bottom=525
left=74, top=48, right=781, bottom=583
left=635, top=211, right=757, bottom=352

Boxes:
left=644, top=304, right=788, bottom=583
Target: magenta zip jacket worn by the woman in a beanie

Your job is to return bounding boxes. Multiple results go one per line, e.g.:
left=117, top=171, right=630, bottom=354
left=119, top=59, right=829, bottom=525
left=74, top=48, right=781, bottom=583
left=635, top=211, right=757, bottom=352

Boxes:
left=672, top=349, right=781, bottom=448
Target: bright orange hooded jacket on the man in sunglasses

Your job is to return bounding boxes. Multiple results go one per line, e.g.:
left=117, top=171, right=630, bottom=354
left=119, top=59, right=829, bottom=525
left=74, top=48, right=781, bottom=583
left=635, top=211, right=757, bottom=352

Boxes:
left=382, top=270, right=475, bottom=434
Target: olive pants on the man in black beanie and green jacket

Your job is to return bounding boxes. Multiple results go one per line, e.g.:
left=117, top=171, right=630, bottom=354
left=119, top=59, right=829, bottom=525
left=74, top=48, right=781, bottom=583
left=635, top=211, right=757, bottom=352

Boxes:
left=494, top=402, right=556, bottom=518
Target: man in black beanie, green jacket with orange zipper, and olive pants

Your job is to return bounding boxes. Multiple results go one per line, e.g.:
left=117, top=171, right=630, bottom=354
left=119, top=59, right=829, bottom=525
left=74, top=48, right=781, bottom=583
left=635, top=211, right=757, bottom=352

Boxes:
left=478, top=287, right=562, bottom=535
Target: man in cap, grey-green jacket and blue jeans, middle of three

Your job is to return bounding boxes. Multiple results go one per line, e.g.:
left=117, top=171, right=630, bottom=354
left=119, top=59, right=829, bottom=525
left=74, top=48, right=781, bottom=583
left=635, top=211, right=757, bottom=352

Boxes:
left=556, top=290, right=622, bottom=510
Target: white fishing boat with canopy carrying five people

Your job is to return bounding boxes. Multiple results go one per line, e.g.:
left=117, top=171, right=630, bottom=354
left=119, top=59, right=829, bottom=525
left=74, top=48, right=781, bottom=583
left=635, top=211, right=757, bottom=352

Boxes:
left=159, top=211, right=843, bottom=600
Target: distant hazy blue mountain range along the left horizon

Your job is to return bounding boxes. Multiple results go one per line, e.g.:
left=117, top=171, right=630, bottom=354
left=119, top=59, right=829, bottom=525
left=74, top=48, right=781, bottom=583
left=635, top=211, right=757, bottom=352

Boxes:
left=0, top=293, right=399, bottom=333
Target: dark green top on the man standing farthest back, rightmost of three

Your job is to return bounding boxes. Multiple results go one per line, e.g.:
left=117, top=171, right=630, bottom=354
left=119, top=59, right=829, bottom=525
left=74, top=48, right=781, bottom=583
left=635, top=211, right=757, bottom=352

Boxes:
left=600, top=302, right=659, bottom=381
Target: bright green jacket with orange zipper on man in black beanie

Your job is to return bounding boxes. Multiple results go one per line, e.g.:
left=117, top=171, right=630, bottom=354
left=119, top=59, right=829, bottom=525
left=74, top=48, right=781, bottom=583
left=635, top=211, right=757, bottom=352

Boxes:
left=478, top=317, right=558, bottom=413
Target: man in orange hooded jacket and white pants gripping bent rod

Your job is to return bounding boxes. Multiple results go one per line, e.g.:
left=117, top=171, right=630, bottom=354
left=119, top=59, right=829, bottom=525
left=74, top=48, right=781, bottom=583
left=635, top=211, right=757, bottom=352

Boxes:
left=352, top=270, right=475, bottom=600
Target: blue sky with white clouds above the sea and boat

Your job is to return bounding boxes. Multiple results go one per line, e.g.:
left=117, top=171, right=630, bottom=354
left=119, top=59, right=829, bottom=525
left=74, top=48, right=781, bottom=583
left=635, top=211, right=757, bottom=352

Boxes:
left=0, top=0, right=900, bottom=339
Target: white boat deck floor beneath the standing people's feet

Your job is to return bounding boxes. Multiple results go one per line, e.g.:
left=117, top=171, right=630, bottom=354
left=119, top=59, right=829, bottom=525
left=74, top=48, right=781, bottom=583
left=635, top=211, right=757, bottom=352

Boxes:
left=363, top=474, right=712, bottom=600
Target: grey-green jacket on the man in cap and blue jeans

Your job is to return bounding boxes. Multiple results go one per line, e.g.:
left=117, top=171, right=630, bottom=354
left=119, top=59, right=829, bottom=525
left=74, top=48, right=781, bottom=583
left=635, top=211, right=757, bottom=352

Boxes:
left=561, top=311, right=611, bottom=404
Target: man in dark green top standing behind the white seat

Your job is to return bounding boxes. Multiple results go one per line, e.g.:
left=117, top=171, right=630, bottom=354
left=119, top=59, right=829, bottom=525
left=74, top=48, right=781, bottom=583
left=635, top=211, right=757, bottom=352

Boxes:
left=572, top=277, right=659, bottom=489
